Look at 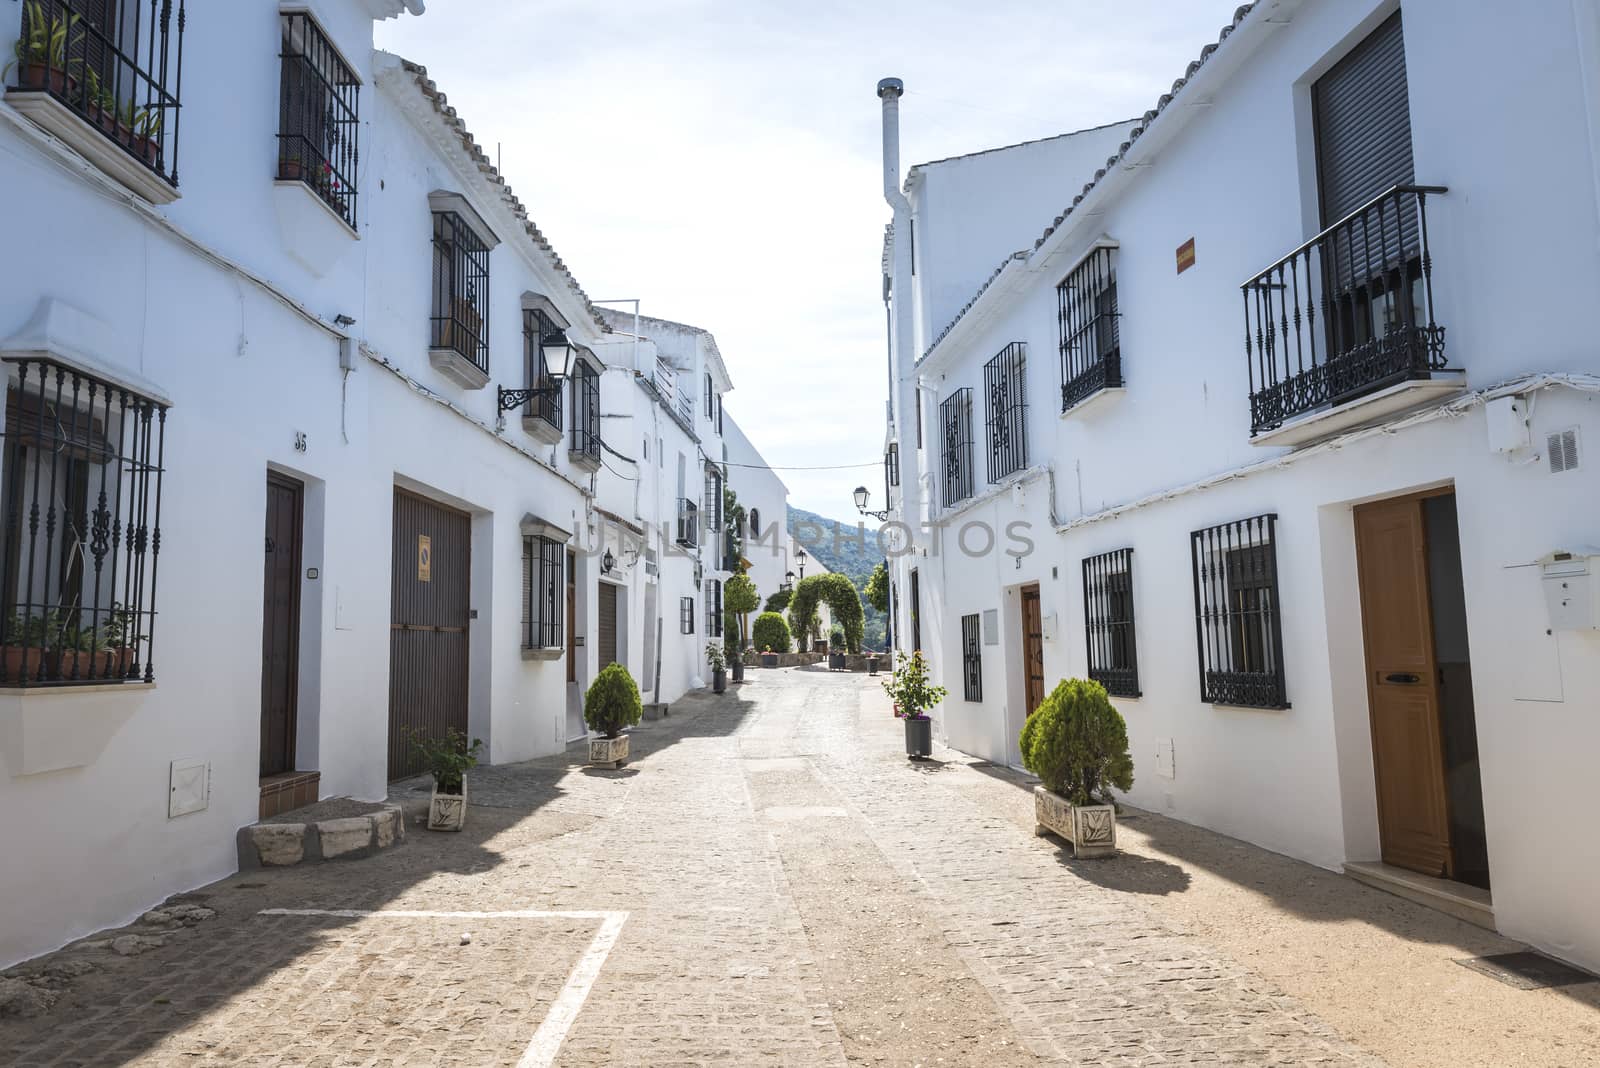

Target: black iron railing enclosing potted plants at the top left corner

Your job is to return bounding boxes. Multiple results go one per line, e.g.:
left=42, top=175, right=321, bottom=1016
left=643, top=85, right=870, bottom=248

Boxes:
left=6, top=0, right=187, bottom=185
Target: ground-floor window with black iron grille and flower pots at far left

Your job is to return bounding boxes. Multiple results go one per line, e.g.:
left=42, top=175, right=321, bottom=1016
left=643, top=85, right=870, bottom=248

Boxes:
left=0, top=358, right=171, bottom=686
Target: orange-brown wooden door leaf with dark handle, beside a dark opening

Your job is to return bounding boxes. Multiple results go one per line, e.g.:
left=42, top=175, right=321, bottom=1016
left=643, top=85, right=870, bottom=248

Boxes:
left=1355, top=497, right=1453, bottom=878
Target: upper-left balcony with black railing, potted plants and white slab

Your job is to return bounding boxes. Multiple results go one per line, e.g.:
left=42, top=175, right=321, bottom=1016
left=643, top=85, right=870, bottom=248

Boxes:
left=6, top=0, right=187, bottom=205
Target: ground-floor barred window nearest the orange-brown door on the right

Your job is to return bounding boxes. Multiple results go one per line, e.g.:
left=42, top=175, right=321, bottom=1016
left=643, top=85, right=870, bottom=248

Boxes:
left=1189, top=515, right=1290, bottom=708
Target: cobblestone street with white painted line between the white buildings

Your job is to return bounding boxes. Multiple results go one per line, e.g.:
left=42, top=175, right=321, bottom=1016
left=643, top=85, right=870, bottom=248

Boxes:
left=0, top=668, right=1600, bottom=1068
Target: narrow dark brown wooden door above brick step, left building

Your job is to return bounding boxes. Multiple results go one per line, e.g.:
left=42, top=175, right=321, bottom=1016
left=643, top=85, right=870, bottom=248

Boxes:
left=261, top=473, right=306, bottom=775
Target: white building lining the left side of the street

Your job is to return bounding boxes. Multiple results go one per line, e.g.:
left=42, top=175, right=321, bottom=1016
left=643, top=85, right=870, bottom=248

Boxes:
left=0, top=0, right=726, bottom=966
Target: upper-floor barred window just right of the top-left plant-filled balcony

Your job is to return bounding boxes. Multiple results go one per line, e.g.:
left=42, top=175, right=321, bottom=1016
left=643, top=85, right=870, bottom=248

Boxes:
left=278, top=11, right=362, bottom=227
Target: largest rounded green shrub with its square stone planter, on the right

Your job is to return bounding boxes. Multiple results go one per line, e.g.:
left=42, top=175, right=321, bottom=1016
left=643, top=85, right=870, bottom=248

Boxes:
left=1019, top=678, right=1133, bottom=857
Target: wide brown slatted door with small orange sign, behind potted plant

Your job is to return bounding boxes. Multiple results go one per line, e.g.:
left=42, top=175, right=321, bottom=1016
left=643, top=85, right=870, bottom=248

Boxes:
left=389, top=489, right=472, bottom=779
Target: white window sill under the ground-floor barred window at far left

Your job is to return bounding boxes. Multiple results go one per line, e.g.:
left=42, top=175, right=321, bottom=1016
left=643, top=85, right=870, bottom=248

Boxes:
left=0, top=683, right=155, bottom=779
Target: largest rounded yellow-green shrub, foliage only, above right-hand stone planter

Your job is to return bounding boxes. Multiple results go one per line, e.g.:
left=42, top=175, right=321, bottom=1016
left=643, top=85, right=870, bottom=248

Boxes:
left=1019, top=678, right=1133, bottom=804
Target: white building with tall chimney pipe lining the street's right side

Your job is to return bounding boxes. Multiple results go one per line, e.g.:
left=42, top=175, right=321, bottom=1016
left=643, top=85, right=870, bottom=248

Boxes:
left=880, top=0, right=1600, bottom=967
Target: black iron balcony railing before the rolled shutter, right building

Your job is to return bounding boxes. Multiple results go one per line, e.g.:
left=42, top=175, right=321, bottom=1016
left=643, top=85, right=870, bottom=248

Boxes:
left=1240, top=185, right=1448, bottom=436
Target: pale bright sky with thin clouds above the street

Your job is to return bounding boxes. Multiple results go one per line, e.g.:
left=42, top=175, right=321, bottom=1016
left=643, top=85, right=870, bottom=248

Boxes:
left=378, top=0, right=1237, bottom=520
